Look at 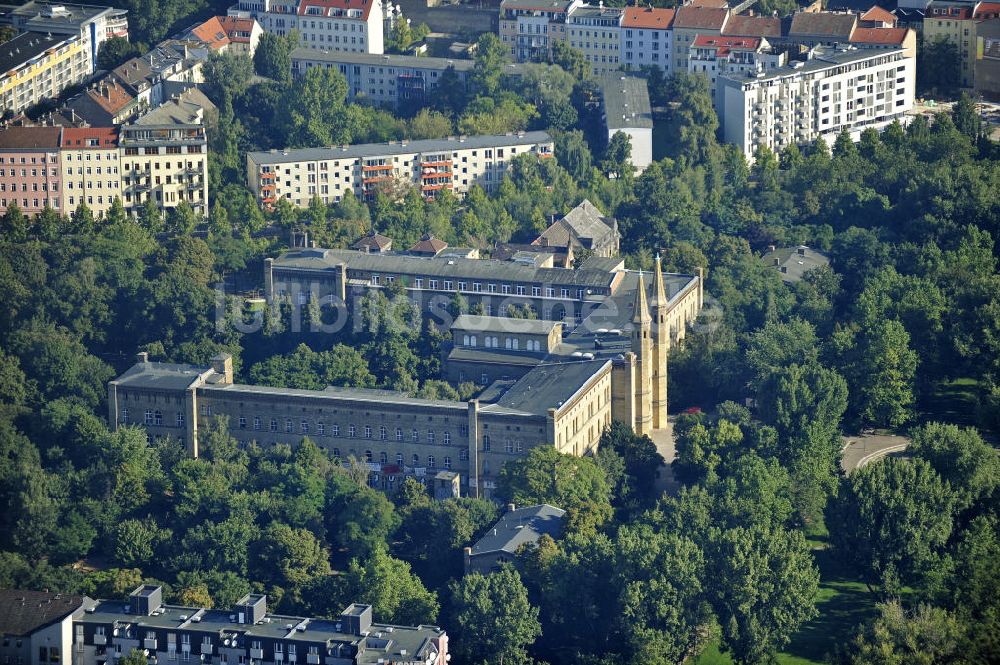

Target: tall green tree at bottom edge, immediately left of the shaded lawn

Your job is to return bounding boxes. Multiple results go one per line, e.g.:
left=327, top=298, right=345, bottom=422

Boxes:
left=706, top=527, right=819, bottom=664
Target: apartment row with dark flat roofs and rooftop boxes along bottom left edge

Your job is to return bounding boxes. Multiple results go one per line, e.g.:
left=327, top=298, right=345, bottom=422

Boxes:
left=0, top=584, right=449, bottom=665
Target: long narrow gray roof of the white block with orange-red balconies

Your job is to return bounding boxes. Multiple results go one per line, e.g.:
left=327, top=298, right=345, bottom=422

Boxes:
left=247, top=131, right=552, bottom=164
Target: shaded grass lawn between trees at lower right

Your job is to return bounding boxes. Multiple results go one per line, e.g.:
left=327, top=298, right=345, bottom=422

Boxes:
left=693, top=544, right=875, bottom=665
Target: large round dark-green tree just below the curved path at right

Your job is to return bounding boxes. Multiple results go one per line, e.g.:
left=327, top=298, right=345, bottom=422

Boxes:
left=827, top=458, right=955, bottom=593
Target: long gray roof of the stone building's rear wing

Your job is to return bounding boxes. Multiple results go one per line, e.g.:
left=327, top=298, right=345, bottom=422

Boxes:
left=274, top=249, right=618, bottom=288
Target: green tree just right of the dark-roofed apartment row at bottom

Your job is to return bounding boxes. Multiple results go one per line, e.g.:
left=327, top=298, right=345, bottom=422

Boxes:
left=451, top=566, right=542, bottom=665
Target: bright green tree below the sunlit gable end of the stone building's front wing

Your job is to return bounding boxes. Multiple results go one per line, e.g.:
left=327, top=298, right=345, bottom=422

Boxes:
left=497, top=446, right=611, bottom=532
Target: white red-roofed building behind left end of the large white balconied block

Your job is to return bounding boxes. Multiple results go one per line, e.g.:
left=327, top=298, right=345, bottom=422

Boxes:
left=688, top=35, right=788, bottom=112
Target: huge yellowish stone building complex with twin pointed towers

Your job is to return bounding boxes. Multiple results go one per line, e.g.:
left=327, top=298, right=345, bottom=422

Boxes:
left=108, top=249, right=702, bottom=497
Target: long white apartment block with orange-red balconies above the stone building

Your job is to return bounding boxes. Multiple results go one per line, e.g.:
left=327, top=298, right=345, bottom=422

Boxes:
left=247, top=132, right=553, bottom=207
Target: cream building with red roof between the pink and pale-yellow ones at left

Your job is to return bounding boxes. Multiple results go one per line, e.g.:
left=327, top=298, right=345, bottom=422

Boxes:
left=59, top=127, right=121, bottom=217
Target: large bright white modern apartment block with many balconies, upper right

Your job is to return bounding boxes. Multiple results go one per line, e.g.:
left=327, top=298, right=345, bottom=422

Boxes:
left=719, top=47, right=916, bottom=159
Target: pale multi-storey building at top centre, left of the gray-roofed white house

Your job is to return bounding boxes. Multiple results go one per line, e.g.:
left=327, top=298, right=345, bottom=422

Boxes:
left=500, top=0, right=583, bottom=62
